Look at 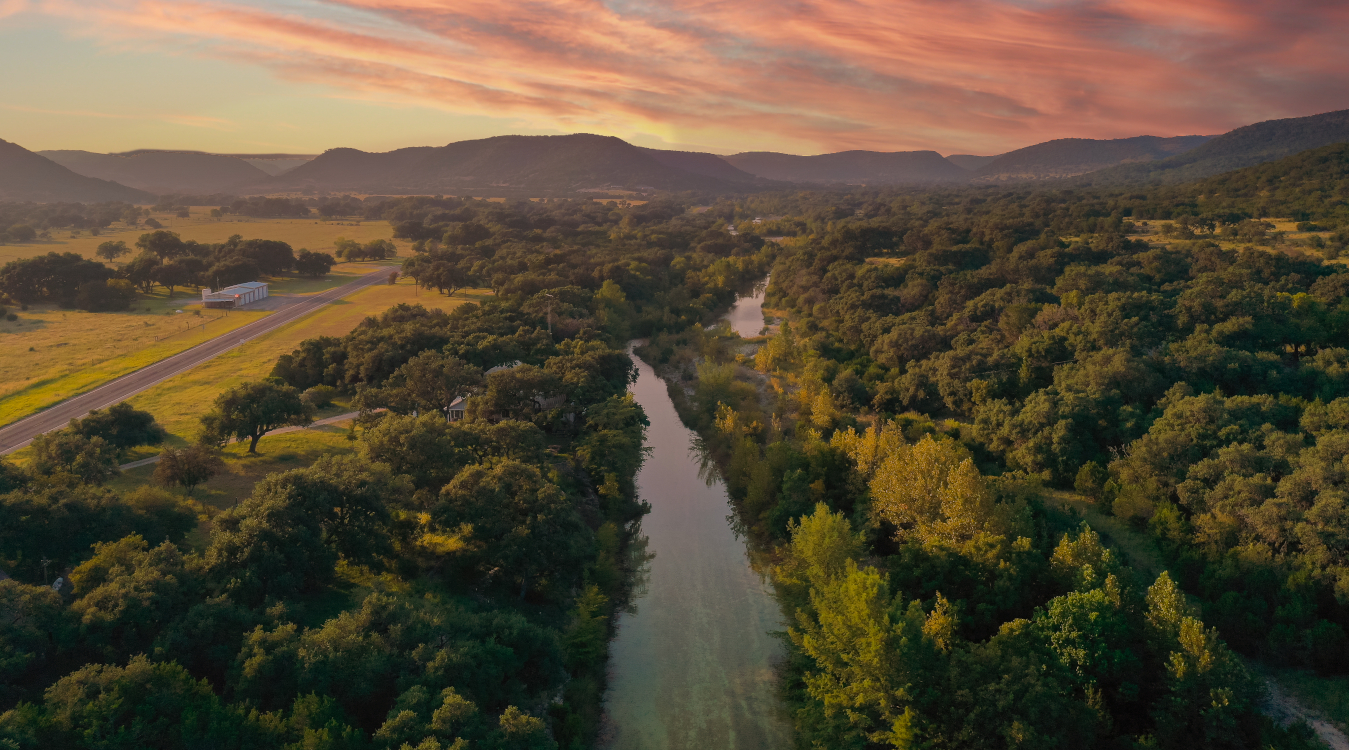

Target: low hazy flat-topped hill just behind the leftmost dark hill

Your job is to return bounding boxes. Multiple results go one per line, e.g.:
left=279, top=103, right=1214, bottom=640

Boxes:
left=40, top=150, right=271, bottom=194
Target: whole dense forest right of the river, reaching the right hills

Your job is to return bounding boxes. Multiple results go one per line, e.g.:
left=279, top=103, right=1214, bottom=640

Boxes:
left=641, top=146, right=1349, bottom=749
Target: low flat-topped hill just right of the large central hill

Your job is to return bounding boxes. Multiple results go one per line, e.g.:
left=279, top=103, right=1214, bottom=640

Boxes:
left=722, top=151, right=969, bottom=185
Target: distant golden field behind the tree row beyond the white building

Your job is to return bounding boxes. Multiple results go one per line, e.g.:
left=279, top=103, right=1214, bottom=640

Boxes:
left=0, top=206, right=411, bottom=264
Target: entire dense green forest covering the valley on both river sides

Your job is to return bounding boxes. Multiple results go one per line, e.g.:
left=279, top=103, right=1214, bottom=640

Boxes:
left=0, top=138, right=1349, bottom=750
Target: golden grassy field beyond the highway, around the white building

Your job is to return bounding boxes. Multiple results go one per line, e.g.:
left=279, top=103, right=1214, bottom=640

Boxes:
left=0, top=263, right=399, bottom=425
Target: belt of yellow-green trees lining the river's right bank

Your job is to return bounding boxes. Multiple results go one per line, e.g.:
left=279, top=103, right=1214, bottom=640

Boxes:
left=642, top=324, right=1314, bottom=749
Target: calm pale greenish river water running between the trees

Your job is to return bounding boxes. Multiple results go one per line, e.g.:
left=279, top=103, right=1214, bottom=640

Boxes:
left=600, top=283, right=791, bottom=750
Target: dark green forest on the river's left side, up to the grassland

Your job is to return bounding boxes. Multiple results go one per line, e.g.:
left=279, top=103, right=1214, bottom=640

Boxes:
left=0, top=198, right=769, bottom=750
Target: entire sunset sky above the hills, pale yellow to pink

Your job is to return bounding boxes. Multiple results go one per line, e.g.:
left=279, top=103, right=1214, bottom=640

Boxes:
left=0, top=0, right=1349, bottom=154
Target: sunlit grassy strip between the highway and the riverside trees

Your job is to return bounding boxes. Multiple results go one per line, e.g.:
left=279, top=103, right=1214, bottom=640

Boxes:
left=131, top=279, right=482, bottom=442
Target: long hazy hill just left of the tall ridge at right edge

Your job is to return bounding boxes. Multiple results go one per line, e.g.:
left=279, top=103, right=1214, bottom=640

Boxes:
left=971, top=135, right=1213, bottom=182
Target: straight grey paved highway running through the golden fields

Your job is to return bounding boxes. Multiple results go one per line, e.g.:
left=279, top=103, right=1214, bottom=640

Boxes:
left=0, top=268, right=394, bottom=453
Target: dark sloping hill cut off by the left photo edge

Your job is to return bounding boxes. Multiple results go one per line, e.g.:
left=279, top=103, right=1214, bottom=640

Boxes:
left=0, top=140, right=155, bottom=204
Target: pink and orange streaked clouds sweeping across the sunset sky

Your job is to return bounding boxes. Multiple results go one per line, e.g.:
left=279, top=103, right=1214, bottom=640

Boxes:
left=26, top=0, right=1349, bottom=152
